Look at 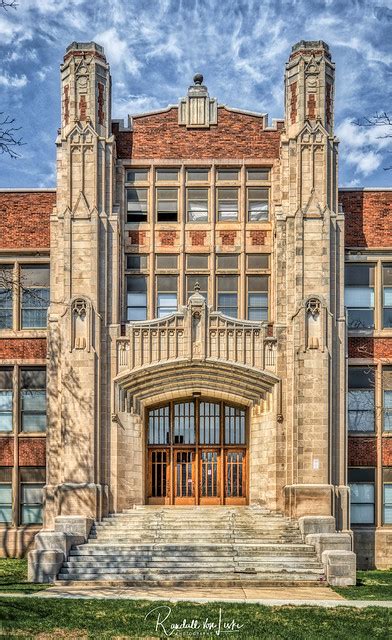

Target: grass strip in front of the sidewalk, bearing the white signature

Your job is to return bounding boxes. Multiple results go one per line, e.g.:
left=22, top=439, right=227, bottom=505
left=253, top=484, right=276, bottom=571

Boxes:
left=0, top=597, right=392, bottom=640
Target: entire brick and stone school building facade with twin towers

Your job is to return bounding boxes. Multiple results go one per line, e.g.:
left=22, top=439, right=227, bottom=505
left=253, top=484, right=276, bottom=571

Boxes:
left=0, top=42, right=392, bottom=567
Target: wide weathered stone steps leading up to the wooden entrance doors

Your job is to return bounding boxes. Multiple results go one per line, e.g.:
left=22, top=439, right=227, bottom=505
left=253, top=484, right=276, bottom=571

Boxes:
left=57, top=506, right=325, bottom=586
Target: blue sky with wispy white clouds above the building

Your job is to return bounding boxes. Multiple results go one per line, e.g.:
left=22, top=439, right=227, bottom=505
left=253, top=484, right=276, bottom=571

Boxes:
left=0, top=0, right=392, bottom=187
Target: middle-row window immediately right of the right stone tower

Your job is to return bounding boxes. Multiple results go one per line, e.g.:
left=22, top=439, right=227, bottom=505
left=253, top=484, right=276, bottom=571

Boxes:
left=348, top=367, right=375, bottom=432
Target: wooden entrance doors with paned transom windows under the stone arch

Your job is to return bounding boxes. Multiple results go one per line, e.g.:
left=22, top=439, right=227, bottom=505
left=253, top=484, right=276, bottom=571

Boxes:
left=146, top=397, right=248, bottom=505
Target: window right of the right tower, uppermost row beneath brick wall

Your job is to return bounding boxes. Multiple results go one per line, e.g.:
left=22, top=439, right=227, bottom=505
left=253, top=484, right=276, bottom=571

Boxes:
left=345, top=264, right=374, bottom=330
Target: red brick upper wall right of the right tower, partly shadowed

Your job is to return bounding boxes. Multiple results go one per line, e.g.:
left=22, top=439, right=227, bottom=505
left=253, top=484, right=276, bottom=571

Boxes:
left=339, top=191, right=392, bottom=247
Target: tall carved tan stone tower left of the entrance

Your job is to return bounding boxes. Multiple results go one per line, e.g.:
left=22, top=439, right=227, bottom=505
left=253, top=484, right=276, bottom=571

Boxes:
left=45, top=42, right=119, bottom=528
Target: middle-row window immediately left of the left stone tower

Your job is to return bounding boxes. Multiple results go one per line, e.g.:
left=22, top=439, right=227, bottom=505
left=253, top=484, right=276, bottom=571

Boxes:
left=20, top=367, right=46, bottom=433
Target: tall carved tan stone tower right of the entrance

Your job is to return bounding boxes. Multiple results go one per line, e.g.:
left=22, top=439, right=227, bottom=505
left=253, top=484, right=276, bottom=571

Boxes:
left=275, top=41, right=348, bottom=528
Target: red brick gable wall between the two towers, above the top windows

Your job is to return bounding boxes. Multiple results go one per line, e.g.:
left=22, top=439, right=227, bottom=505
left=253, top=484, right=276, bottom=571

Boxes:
left=113, top=107, right=281, bottom=160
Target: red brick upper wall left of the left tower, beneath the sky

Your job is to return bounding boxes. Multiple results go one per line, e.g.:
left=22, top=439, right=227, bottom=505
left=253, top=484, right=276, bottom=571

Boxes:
left=0, top=191, right=56, bottom=249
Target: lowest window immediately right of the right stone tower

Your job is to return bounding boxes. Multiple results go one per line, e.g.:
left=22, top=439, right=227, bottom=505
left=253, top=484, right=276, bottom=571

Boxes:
left=348, top=467, right=375, bottom=524
